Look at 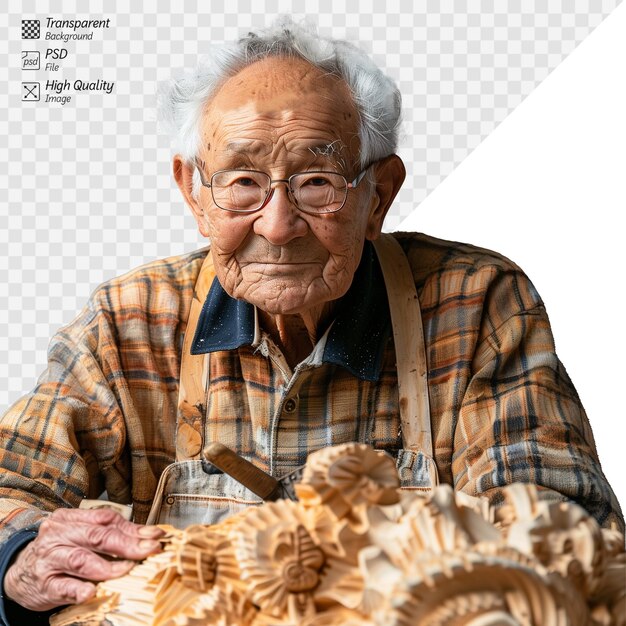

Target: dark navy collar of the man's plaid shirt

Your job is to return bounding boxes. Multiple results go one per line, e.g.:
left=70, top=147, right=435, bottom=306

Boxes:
left=191, top=241, right=391, bottom=381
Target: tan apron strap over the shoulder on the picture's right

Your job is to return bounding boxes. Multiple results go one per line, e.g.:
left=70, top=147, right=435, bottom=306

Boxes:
left=373, top=234, right=434, bottom=465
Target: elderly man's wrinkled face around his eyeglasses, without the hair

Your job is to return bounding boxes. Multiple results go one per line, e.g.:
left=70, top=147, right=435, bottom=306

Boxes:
left=174, top=57, right=402, bottom=314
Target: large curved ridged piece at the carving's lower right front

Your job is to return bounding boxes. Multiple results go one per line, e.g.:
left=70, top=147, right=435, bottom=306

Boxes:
left=363, top=545, right=590, bottom=626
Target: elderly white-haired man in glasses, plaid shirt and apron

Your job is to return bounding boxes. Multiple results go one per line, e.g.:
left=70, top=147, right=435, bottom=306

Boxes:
left=0, top=19, right=623, bottom=623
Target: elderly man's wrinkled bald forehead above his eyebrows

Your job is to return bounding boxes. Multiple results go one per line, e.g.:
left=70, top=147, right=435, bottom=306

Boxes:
left=201, top=57, right=359, bottom=162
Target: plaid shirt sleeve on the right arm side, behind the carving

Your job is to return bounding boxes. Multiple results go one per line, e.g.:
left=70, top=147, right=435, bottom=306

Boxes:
left=452, top=271, right=624, bottom=531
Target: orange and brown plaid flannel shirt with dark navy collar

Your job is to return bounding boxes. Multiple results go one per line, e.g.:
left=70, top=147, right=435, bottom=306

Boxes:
left=0, top=233, right=623, bottom=540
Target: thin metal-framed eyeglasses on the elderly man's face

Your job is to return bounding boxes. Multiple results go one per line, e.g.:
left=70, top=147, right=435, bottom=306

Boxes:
left=190, top=161, right=369, bottom=215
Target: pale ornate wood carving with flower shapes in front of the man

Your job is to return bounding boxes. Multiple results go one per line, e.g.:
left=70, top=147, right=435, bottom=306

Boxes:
left=50, top=444, right=626, bottom=626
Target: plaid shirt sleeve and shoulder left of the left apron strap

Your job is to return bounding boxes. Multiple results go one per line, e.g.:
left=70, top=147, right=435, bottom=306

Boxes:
left=0, top=249, right=193, bottom=542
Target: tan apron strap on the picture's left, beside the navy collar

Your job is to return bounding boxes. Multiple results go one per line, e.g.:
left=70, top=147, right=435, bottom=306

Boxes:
left=176, top=250, right=215, bottom=461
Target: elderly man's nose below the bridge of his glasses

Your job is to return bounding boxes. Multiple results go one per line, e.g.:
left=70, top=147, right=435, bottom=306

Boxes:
left=254, top=180, right=309, bottom=246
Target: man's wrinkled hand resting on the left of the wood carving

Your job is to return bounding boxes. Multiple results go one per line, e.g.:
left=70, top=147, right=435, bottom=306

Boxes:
left=4, top=509, right=164, bottom=611
